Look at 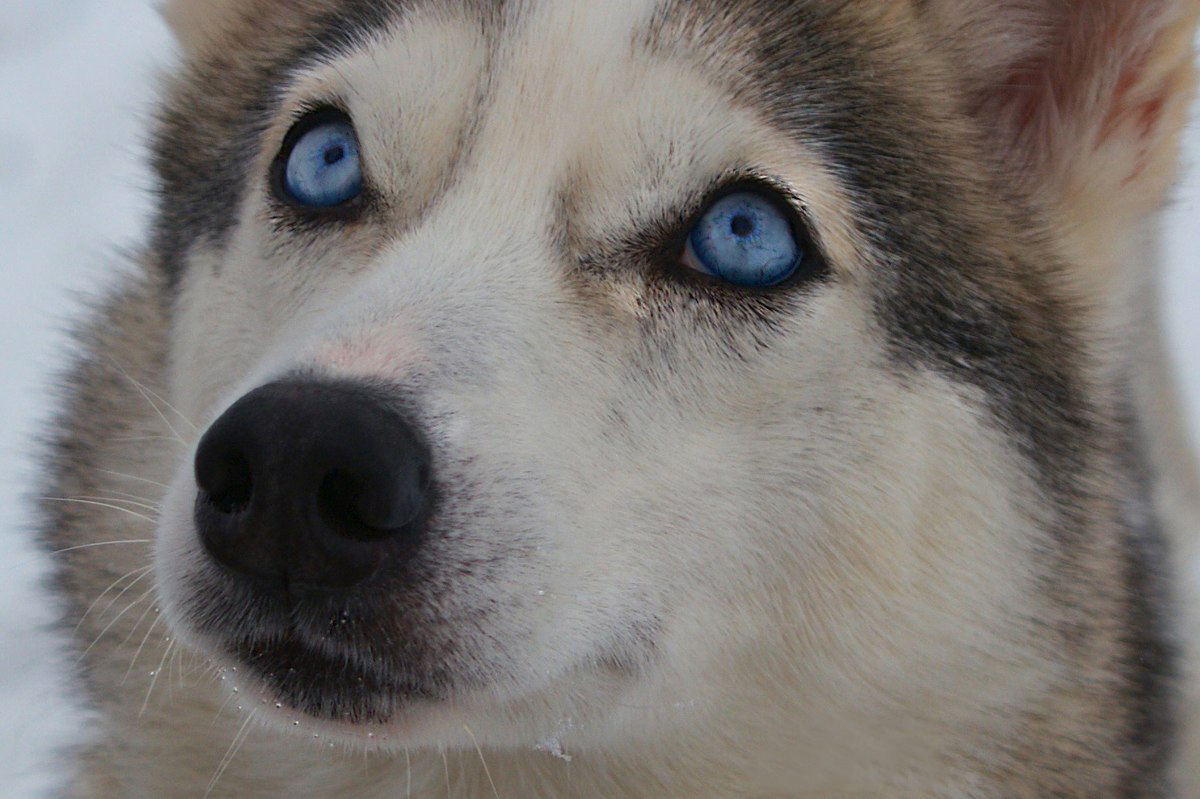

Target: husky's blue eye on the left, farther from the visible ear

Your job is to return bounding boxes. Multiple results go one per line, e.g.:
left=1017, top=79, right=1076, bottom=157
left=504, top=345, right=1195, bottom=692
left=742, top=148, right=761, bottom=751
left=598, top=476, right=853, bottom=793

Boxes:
left=281, top=113, right=362, bottom=209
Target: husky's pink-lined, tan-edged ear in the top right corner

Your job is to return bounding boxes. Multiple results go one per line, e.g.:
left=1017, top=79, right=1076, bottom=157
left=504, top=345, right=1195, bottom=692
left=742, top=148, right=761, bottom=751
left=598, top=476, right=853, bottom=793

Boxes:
left=916, top=0, right=1200, bottom=279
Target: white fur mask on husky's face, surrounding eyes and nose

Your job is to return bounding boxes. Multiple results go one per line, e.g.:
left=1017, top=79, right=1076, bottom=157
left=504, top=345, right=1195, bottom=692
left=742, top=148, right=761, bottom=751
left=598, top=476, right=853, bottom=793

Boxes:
left=147, top=2, right=1039, bottom=795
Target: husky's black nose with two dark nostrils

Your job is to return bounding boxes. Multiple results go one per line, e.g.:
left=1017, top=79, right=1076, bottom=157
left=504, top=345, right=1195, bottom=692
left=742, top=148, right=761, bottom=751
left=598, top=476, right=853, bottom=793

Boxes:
left=189, top=380, right=430, bottom=590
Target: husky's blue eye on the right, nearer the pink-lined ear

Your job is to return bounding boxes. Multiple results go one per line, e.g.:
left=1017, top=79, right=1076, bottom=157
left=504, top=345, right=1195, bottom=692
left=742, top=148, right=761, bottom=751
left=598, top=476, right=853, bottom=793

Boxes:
left=684, top=192, right=806, bottom=288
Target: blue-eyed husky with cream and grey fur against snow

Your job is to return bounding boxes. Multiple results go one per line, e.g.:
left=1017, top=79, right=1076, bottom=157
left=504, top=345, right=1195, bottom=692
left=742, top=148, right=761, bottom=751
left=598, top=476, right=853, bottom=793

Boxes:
left=43, top=0, right=1200, bottom=799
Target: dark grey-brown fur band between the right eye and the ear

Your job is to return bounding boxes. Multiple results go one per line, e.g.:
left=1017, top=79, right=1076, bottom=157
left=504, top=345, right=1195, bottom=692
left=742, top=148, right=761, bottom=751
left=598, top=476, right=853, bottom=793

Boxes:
left=659, top=0, right=1092, bottom=498
